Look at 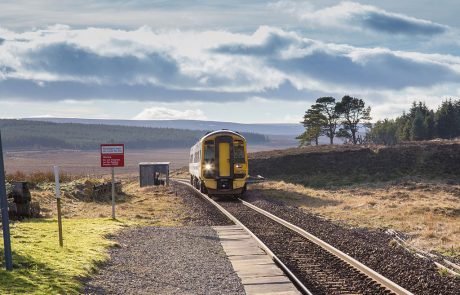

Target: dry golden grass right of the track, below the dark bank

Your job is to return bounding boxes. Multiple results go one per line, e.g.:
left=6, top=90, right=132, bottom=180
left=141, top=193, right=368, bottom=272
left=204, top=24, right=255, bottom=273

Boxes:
left=250, top=180, right=460, bottom=257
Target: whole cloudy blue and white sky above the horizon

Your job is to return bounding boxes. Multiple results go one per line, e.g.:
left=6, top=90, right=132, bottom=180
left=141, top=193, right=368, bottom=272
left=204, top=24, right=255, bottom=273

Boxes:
left=0, top=0, right=460, bottom=123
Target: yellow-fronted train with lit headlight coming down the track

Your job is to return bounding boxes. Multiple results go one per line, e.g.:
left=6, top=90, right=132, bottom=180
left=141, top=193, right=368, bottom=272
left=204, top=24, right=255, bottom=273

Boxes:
left=189, top=130, right=248, bottom=195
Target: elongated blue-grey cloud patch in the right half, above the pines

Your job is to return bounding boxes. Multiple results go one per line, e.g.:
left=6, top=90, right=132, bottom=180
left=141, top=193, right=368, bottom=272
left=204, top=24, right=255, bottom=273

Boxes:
left=271, top=49, right=460, bottom=89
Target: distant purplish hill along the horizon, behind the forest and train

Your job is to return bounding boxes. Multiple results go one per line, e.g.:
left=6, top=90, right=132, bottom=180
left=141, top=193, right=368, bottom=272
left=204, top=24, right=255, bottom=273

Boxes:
left=25, top=118, right=304, bottom=138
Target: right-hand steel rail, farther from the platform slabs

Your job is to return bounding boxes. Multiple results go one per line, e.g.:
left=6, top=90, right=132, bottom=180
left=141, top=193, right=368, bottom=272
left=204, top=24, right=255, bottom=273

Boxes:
left=243, top=199, right=413, bottom=295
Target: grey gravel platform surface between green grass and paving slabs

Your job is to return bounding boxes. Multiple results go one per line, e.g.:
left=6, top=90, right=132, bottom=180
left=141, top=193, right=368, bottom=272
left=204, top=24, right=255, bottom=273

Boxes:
left=85, top=226, right=245, bottom=295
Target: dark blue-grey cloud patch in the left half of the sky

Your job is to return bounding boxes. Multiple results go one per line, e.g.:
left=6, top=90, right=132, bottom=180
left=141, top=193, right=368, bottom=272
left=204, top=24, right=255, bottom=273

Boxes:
left=22, top=42, right=179, bottom=83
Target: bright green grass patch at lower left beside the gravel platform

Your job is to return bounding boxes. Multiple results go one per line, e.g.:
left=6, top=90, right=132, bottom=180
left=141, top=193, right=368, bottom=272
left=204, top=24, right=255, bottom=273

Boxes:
left=0, top=219, right=126, bottom=294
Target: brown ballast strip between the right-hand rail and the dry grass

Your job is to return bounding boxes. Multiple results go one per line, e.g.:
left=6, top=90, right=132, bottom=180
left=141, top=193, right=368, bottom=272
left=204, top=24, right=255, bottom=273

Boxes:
left=244, top=198, right=460, bottom=295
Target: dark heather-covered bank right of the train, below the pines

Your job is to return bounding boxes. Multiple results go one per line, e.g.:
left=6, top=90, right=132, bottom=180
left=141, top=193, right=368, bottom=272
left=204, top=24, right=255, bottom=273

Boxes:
left=249, top=141, right=460, bottom=185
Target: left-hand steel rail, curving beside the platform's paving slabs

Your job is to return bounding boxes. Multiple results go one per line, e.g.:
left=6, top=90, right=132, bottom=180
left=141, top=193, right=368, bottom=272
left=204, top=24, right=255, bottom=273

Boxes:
left=171, top=179, right=313, bottom=295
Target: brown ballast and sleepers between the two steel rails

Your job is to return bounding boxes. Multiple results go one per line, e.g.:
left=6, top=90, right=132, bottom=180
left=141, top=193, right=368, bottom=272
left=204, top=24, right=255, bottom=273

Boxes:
left=176, top=182, right=412, bottom=294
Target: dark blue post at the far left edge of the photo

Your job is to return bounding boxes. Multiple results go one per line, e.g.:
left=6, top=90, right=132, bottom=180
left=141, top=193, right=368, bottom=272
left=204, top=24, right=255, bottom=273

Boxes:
left=0, top=132, right=13, bottom=271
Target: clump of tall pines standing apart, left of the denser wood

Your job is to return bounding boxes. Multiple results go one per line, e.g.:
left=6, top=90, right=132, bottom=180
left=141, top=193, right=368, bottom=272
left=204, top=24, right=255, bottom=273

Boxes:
left=296, top=95, right=371, bottom=146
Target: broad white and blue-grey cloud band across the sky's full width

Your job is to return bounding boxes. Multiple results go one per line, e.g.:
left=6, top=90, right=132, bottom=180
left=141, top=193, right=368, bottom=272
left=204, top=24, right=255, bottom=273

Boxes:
left=0, top=25, right=460, bottom=102
